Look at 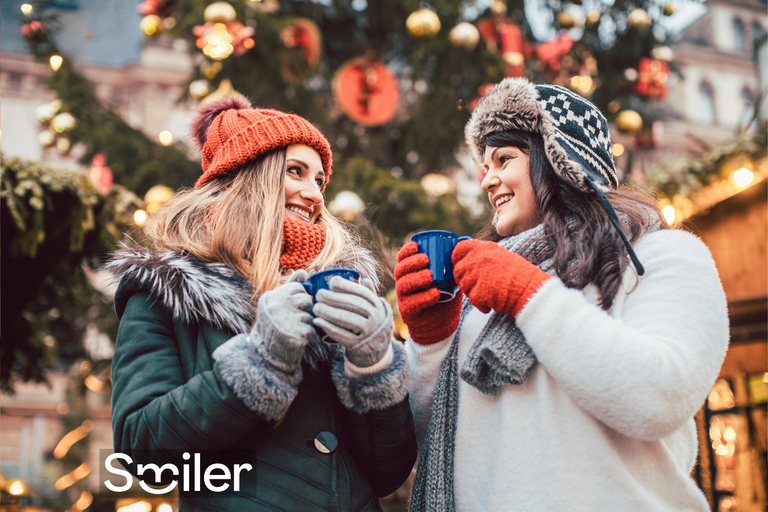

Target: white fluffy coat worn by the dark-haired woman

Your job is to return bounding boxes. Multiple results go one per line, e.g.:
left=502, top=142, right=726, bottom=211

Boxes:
left=406, top=230, right=728, bottom=512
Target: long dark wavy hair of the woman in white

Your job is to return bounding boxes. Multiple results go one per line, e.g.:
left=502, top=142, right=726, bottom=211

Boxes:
left=475, top=131, right=669, bottom=310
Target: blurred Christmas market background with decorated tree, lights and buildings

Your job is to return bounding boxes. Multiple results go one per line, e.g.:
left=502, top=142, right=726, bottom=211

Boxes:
left=0, top=0, right=768, bottom=512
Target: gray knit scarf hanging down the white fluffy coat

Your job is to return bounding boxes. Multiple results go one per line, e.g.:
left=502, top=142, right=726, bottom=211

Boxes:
left=410, top=224, right=554, bottom=512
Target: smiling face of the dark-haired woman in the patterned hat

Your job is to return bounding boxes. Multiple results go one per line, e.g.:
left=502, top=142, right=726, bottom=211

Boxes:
left=481, top=146, right=542, bottom=236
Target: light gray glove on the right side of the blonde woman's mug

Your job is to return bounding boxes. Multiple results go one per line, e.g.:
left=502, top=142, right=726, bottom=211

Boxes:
left=312, top=277, right=394, bottom=367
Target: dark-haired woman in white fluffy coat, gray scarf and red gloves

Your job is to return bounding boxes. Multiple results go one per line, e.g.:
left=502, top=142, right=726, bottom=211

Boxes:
left=395, top=79, right=728, bottom=512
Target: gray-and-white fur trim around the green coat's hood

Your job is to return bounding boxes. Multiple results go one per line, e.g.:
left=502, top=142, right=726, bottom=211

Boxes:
left=103, top=247, right=380, bottom=333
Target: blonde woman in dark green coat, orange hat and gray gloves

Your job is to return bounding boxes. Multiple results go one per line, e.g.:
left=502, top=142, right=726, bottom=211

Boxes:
left=109, top=99, right=416, bottom=511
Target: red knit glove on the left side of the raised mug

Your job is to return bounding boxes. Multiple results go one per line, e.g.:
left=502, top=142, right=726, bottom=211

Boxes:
left=395, top=242, right=462, bottom=345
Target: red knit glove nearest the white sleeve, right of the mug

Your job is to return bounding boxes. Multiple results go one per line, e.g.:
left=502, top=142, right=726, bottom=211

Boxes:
left=452, top=240, right=552, bottom=316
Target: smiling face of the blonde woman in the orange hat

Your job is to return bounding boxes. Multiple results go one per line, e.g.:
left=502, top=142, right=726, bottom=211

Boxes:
left=283, top=144, right=325, bottom=222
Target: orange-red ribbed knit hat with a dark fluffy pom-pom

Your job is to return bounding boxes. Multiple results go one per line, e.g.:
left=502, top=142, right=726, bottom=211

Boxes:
left=192, top=97, right=332, bottom=191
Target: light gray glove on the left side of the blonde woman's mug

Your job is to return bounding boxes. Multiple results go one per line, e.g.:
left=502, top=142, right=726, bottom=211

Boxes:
left=250, top=270, right=317, bottom=373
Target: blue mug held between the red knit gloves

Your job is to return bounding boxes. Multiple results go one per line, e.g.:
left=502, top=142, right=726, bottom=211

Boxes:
left=411, top=229, right=472, bottom=302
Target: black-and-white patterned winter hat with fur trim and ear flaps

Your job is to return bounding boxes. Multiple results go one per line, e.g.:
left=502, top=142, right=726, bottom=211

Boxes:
left=464, top=78, right=618, bottom=191
